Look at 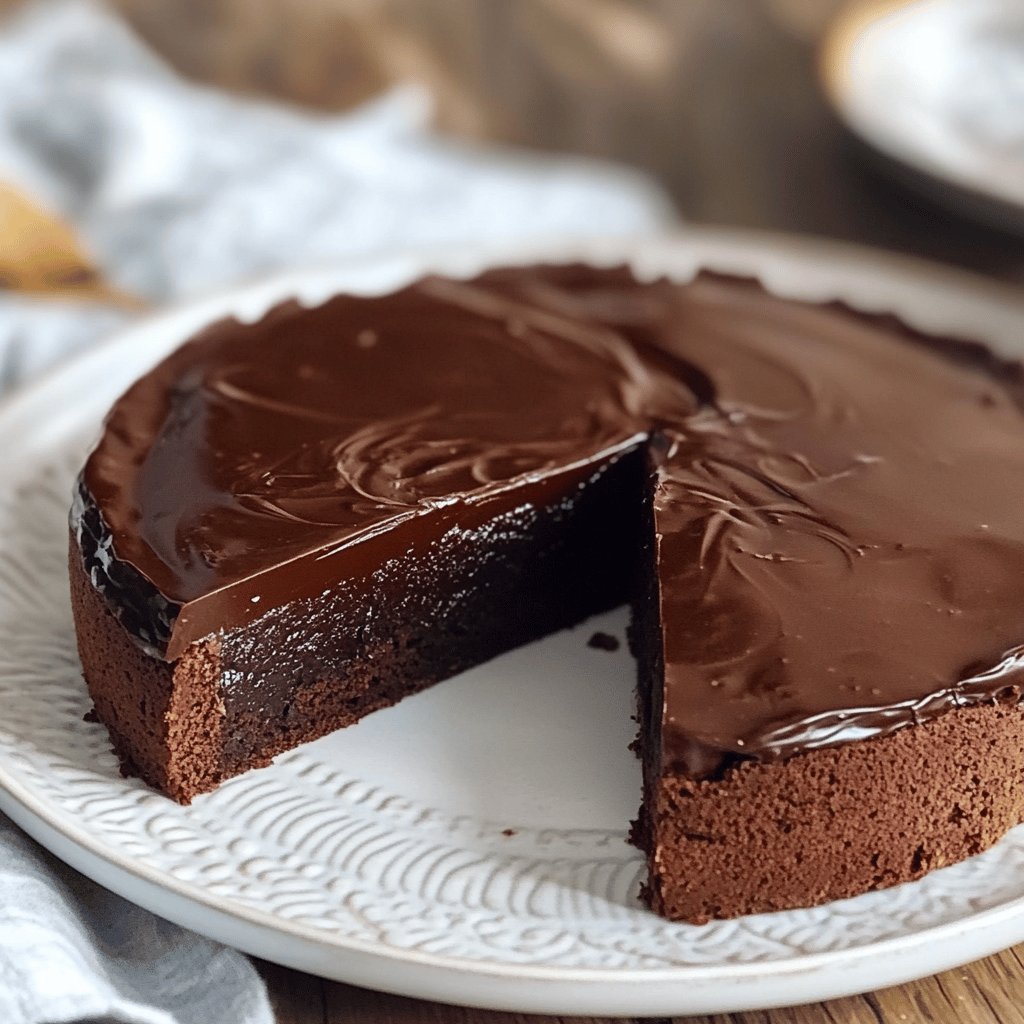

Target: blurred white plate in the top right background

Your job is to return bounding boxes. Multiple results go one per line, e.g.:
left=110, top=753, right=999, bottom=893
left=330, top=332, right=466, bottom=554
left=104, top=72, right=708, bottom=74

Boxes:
left=822, top=0, right=1024, bottom=231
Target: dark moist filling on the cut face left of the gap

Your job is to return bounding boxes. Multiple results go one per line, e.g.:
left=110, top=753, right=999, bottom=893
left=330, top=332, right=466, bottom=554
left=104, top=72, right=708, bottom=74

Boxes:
left=220, top=451, right=644, bottom=761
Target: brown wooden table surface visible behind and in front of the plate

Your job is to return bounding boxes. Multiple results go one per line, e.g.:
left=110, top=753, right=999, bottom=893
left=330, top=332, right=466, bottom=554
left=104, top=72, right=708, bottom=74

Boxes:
left=8, top=0, right=1024, bottom=1024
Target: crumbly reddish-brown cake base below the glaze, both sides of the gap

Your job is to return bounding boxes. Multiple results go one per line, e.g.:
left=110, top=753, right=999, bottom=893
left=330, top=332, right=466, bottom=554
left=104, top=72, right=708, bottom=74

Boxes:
left=71, top=528, right=1024, bottom=924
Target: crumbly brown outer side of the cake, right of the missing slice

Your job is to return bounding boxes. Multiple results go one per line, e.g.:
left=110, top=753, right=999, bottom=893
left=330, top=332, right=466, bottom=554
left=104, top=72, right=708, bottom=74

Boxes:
left=635, top=703, right=1024, bottom=924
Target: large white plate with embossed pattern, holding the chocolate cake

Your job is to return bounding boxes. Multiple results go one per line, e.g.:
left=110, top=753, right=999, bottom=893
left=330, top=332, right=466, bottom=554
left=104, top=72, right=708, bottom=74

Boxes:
left=0, top=232, right=1024, bottom=1016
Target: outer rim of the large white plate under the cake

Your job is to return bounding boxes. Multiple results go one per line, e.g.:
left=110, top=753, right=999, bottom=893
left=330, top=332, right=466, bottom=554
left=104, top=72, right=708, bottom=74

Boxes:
left=0, top=229, right=1024, bottom=1015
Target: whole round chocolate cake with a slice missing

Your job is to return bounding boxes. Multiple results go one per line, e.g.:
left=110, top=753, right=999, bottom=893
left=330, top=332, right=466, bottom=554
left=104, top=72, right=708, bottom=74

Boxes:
left=70, top=265, right=1024, bottom=922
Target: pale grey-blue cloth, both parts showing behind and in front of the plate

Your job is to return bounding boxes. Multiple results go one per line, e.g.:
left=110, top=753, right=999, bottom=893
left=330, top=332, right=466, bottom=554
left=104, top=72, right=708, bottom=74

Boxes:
left=0, top=0, right=671, bottom=1024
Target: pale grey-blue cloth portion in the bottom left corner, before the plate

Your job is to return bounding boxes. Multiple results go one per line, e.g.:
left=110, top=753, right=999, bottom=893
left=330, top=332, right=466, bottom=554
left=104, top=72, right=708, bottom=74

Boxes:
left=0, top=815, right=273, bottom=1024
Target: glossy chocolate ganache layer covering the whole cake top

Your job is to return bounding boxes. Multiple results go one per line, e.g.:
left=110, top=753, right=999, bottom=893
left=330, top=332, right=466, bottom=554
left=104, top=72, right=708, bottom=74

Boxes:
left=73, top=266, right=1024, bottom=776
